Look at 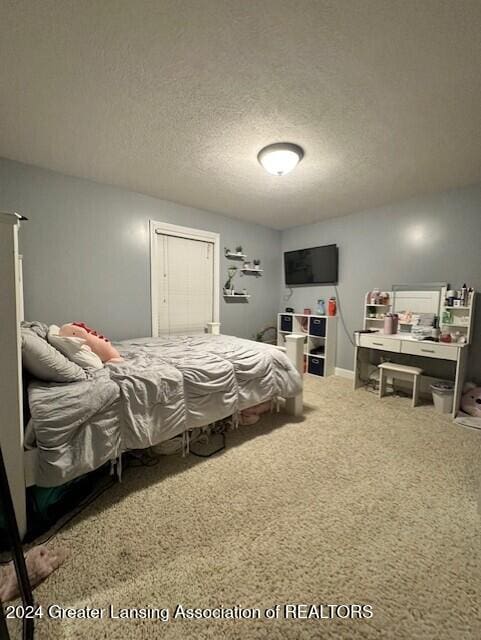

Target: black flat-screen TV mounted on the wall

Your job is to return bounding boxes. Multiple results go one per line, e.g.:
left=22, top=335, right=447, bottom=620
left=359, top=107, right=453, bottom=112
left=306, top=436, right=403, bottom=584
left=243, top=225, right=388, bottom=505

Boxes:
left=284, top=244, right=339, bottom=286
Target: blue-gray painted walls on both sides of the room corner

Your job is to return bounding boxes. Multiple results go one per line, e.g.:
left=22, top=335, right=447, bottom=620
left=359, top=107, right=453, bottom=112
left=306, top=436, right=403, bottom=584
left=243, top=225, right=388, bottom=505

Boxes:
left=0, top=159, right=481, bottom=382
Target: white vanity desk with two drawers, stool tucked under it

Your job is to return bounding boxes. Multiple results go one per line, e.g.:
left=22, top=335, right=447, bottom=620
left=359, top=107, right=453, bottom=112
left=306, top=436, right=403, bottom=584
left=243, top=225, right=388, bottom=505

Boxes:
left=354, top=331, right=469, bottom=417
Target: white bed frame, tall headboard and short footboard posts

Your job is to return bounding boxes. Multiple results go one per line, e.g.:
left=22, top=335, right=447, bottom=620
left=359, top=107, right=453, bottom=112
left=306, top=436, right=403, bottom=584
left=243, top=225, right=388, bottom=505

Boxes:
left=0, top=212, right=304, bottom=539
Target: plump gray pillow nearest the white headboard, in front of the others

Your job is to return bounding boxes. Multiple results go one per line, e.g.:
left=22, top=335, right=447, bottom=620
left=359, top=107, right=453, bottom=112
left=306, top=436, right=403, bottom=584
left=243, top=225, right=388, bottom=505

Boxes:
left=22, top=328, right=87, bottom=382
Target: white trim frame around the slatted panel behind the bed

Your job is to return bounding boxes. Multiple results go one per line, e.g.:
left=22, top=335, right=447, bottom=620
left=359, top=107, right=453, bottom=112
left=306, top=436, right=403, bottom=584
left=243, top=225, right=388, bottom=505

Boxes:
left=149, top=220, right=220, bottom=338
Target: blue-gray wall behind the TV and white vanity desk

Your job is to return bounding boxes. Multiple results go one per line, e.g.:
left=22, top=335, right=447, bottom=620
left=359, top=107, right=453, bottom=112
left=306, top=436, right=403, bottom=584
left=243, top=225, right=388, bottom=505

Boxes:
left=280, top=186, right=481, bottom=382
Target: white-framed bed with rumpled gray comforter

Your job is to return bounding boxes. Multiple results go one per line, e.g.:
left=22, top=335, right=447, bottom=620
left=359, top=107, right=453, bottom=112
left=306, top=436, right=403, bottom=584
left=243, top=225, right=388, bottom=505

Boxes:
left=0, top=213, right=304, bottom=536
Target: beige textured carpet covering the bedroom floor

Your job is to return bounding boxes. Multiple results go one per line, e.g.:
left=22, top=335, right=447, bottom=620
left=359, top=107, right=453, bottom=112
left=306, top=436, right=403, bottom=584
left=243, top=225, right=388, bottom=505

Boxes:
left=6, top=378, right=481, bottom=640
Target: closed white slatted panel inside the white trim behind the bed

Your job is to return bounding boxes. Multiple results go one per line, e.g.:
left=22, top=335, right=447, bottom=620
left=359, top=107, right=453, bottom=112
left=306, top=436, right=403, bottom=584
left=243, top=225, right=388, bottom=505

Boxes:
left=156, top=233, right=214, bottom=336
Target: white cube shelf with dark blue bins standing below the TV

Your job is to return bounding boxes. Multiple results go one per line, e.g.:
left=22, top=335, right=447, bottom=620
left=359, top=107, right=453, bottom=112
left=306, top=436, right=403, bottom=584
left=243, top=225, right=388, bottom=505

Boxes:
left=277, top=313, right=337, bottom=378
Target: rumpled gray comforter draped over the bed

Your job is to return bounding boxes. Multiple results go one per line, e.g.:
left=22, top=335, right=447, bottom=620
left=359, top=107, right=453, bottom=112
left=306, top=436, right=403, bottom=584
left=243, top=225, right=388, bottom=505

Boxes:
left=28, top=334, right=302, bottom=487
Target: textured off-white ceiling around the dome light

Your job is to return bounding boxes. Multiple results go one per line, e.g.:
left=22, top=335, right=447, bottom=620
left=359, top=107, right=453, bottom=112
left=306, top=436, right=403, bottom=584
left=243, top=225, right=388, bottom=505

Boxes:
left=0, top=0, right=481, bottom=228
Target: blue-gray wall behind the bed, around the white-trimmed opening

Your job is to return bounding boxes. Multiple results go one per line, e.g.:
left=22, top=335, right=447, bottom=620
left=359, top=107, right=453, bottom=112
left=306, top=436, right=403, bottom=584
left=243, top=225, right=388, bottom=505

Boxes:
left=0, top=159, right=280, bottom=339
